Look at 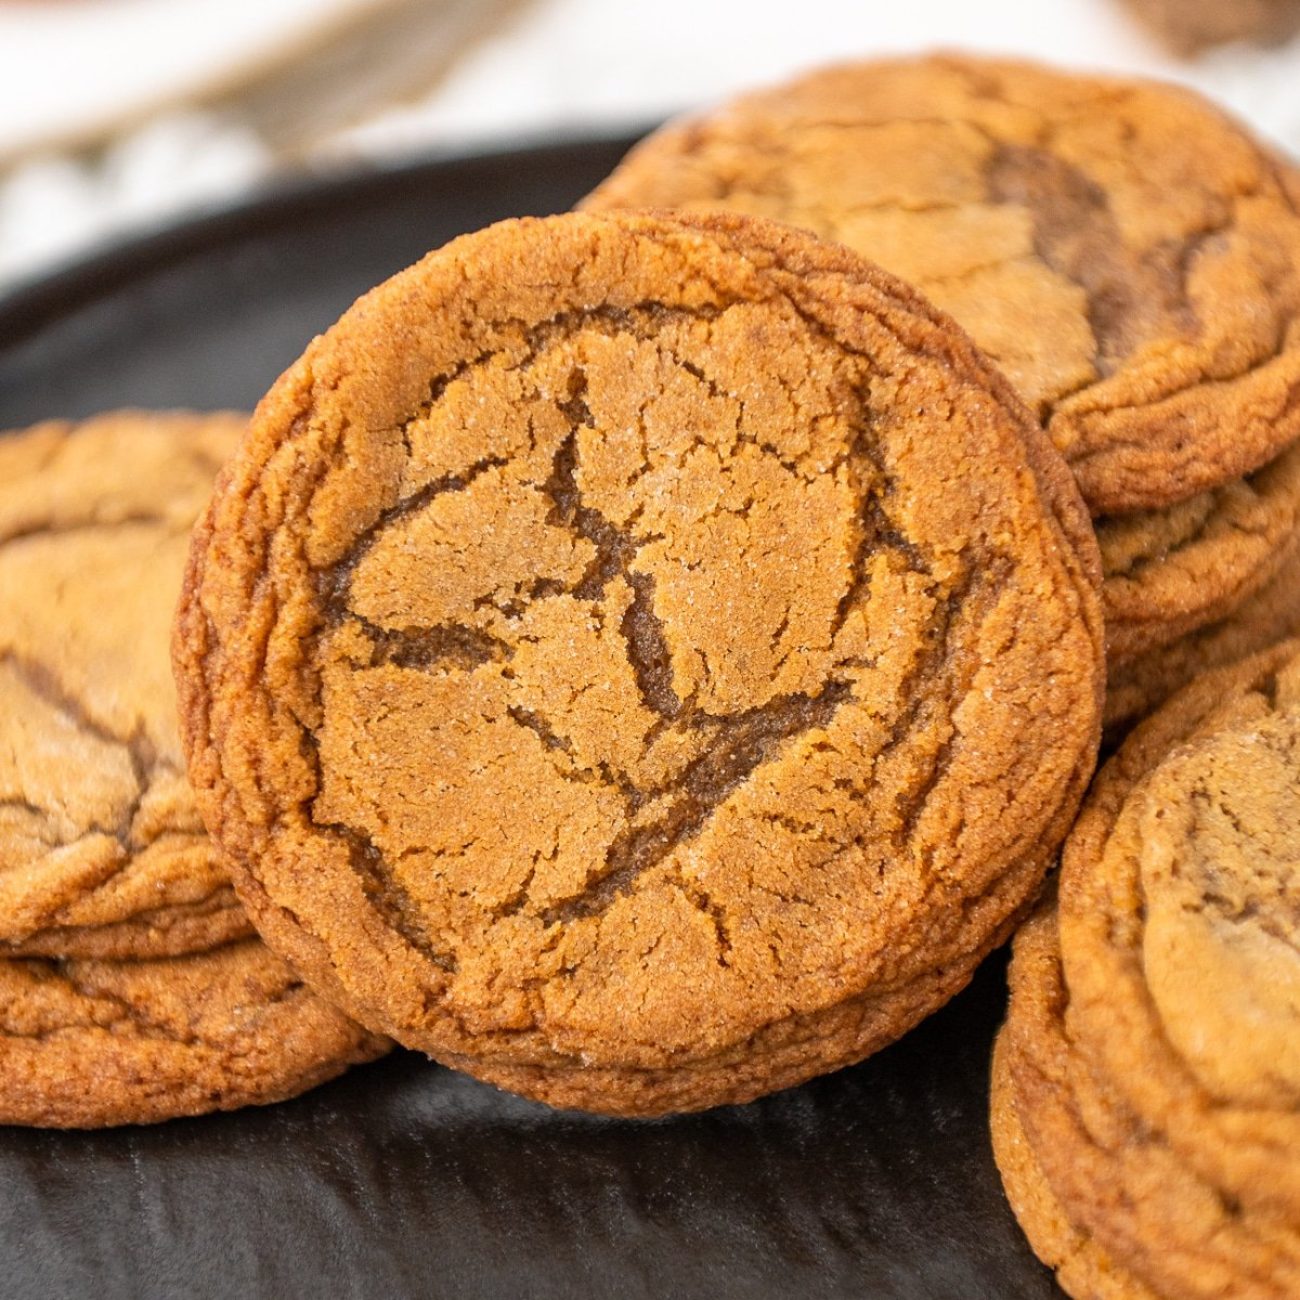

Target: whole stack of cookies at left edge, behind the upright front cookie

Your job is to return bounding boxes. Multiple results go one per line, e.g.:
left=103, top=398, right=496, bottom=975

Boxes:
left=0, top=412, right=384, bottom=1127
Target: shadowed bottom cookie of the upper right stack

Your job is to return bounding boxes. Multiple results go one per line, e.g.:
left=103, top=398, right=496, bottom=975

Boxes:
left=1105, top=522, right=1300, bottom=745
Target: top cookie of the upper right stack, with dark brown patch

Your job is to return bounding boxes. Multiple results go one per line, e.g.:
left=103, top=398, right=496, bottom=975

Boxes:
left=585, top=57, right=1300, bottom=515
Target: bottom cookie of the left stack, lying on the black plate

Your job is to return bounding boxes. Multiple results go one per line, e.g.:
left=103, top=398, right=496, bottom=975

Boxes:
left=0, top=939, right=389, bottom=1128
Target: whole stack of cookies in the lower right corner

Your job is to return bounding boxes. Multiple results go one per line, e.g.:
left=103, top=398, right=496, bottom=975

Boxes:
left=992, top=641, right=1300, bottom=1300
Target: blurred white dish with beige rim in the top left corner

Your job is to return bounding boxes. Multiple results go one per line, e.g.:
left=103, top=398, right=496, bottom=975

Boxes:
left=0, top=0, right=525, bottom=164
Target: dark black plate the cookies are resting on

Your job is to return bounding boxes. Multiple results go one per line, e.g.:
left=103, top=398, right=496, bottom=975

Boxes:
left=0, top=140, right=1060, bottom=1300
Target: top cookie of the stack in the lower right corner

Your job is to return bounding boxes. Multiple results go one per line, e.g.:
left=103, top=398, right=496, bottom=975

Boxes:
left=1060, top=642, right=1300, bottom=1222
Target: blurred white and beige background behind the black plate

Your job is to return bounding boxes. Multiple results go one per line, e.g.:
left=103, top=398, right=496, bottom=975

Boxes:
left=0, top=0, right=1300, bottom=289
